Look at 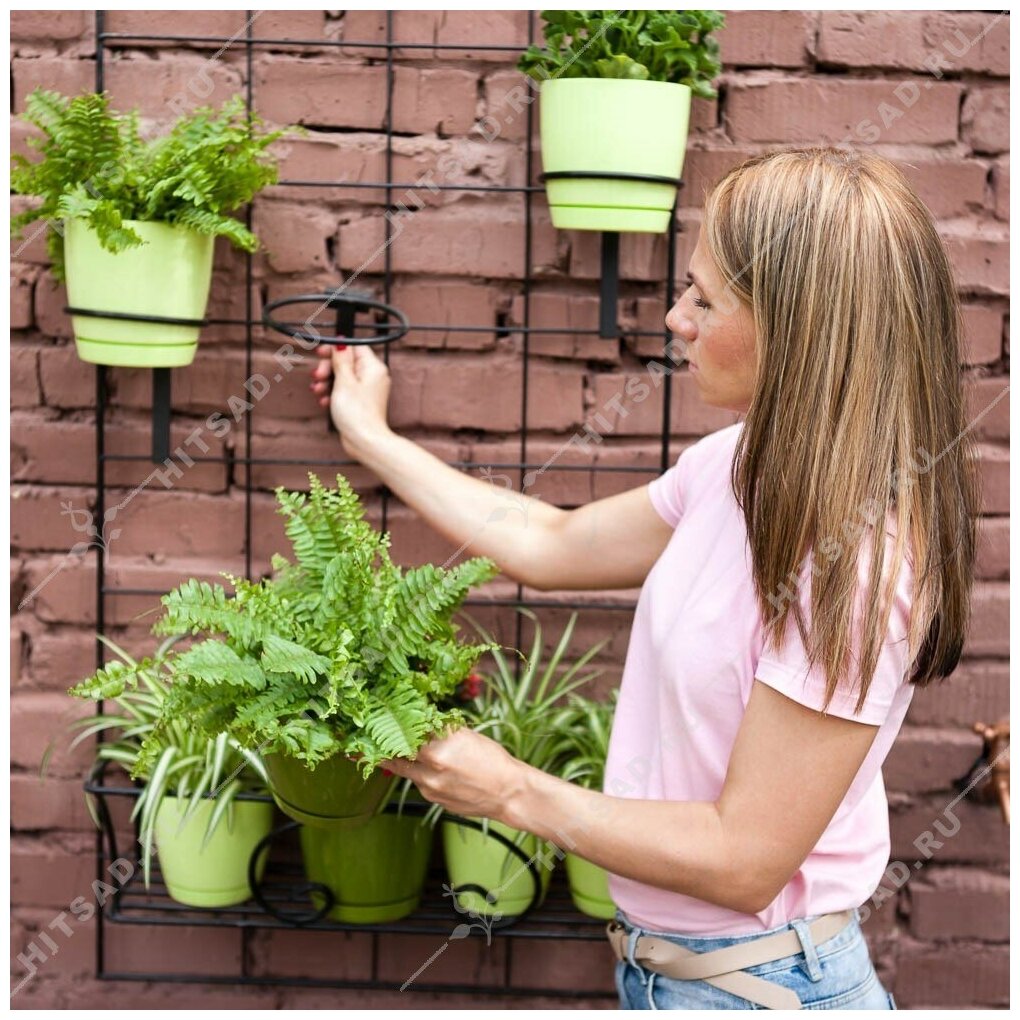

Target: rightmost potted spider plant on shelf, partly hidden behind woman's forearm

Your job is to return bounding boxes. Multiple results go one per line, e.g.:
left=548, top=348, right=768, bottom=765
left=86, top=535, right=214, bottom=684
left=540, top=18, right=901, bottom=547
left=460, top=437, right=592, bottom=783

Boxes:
left=557, top=690, right=619, bottom=921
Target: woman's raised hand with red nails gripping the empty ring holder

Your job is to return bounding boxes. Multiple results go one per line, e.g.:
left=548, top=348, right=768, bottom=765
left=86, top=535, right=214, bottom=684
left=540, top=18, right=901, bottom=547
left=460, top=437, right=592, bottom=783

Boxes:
left=311, top=344, right=391, bottom=459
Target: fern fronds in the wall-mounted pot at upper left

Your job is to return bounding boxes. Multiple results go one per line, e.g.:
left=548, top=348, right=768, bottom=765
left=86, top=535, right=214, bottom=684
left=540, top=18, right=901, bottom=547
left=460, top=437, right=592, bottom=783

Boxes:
left=10, top=89, right=301, bottom=279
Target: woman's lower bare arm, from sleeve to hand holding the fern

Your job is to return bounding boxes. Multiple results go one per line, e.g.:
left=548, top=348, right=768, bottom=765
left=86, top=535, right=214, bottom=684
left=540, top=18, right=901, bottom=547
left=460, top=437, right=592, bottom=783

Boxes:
left=388, top=680, right=878, bottom=914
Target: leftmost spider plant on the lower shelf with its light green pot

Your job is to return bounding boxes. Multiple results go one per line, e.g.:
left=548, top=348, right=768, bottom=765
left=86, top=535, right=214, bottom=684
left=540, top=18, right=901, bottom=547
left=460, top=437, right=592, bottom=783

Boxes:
left=61, top=635, right=272, bottom=907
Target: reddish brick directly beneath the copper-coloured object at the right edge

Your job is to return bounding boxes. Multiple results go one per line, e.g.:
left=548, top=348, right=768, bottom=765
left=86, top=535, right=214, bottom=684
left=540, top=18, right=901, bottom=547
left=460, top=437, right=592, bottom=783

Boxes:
left=889, top=794, right=1010, bottom=872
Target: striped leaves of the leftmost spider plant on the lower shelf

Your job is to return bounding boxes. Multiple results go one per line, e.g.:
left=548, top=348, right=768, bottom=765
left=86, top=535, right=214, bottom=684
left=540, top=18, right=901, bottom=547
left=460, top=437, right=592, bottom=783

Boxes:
left=59, top=634, right=268, bottom=887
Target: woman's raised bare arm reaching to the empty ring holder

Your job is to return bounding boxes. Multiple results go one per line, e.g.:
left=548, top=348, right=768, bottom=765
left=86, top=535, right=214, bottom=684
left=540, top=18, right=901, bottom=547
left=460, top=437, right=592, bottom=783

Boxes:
left=312, top=347, right=672, bottom=591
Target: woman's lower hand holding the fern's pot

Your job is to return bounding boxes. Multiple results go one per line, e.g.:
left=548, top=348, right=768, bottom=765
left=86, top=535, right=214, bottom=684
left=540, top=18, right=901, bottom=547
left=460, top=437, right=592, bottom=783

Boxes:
left=381, top=727, right=527, bottom=821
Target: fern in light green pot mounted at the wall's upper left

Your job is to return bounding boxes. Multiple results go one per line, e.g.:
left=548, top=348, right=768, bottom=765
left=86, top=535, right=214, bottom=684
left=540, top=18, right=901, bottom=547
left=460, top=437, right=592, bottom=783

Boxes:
left=11, top=89, right=297, bottom=368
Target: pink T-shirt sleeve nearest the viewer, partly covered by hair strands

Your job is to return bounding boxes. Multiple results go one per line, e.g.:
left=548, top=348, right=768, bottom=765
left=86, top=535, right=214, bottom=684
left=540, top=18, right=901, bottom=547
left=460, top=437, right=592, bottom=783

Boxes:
left=755, top=540, right=913, bottom=726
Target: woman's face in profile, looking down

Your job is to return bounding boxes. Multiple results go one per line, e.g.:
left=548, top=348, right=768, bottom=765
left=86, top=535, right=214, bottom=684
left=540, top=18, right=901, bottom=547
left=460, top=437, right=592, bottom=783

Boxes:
left=666, top=232, right=757, bottom=414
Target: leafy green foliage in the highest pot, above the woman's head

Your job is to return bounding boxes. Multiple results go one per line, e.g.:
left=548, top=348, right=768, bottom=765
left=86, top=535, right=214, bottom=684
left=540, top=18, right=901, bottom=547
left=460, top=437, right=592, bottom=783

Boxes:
left=517, top=10, right=725, bottom=99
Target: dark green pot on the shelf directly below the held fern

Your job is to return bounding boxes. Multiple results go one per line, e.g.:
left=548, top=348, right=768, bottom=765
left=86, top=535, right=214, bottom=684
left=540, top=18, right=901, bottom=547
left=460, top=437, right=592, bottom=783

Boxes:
left=301, top=799, right=432, bottom=924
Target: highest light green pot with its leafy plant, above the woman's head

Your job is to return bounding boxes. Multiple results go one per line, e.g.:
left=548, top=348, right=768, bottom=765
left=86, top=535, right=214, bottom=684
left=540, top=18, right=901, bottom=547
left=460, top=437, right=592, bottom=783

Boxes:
left=517, top=10, right=724, bottom=234
